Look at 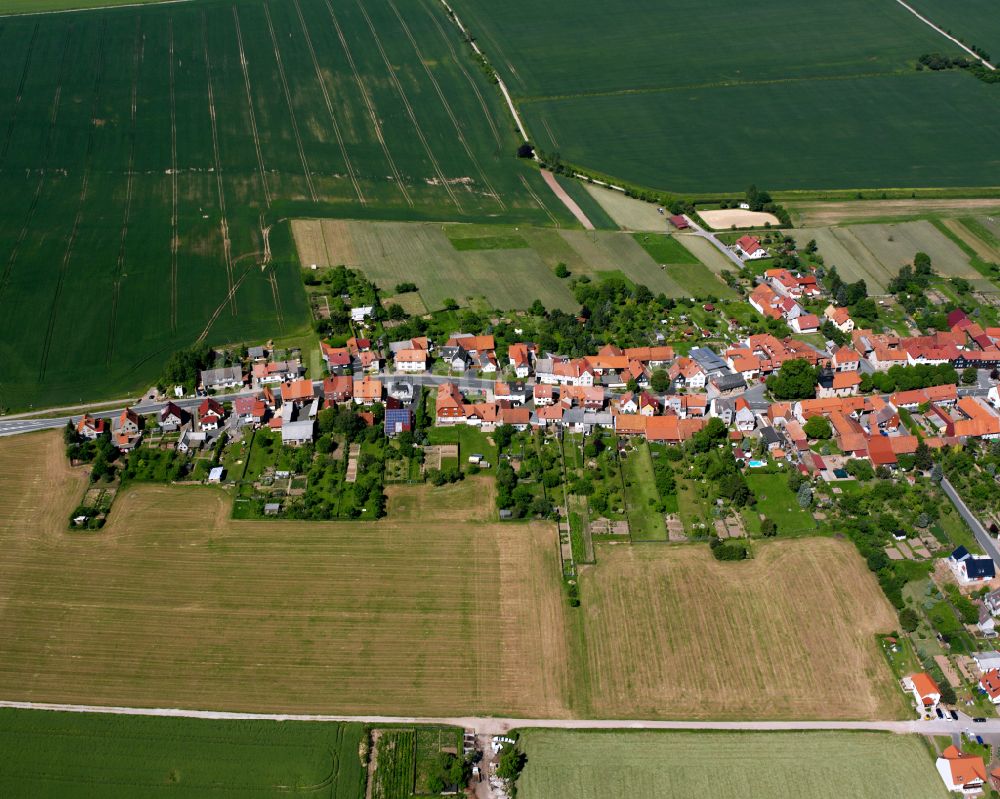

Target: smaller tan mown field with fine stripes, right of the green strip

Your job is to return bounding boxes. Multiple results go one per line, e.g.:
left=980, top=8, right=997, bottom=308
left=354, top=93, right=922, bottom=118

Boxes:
left=577, top=538, right=900, bottom=719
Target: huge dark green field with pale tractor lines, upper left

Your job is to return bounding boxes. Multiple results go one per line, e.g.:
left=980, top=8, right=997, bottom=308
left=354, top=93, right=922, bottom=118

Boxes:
left=0, top=0, right=573, bottom=408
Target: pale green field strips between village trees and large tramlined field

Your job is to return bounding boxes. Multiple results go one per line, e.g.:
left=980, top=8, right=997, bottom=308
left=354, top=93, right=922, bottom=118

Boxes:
left=293, top=220, right=731, bottom=311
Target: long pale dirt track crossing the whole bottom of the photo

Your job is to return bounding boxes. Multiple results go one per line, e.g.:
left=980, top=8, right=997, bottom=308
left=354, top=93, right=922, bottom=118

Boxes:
left=0, top=700, right=984, bottom=735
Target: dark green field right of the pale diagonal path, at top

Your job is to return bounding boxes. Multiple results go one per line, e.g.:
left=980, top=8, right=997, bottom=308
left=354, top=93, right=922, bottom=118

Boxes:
left=453, top=0, right=1000, bottom=193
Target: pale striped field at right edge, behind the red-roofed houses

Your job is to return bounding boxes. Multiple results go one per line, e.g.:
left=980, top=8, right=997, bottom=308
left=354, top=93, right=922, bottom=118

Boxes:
left=794, top=220, right=991, bottom=294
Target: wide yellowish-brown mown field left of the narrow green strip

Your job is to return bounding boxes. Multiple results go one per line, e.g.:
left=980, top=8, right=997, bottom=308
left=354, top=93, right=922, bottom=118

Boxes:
left=0, top=433, right=569, bottom=716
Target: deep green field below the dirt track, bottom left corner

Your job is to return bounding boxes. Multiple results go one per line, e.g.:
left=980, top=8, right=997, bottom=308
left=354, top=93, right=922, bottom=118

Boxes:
left=0, top=709, right=365, bottom=799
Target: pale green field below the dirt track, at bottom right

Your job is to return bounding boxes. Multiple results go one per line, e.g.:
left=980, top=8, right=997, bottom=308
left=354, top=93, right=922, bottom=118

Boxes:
left=518, top=730, right=949, bottom=799
